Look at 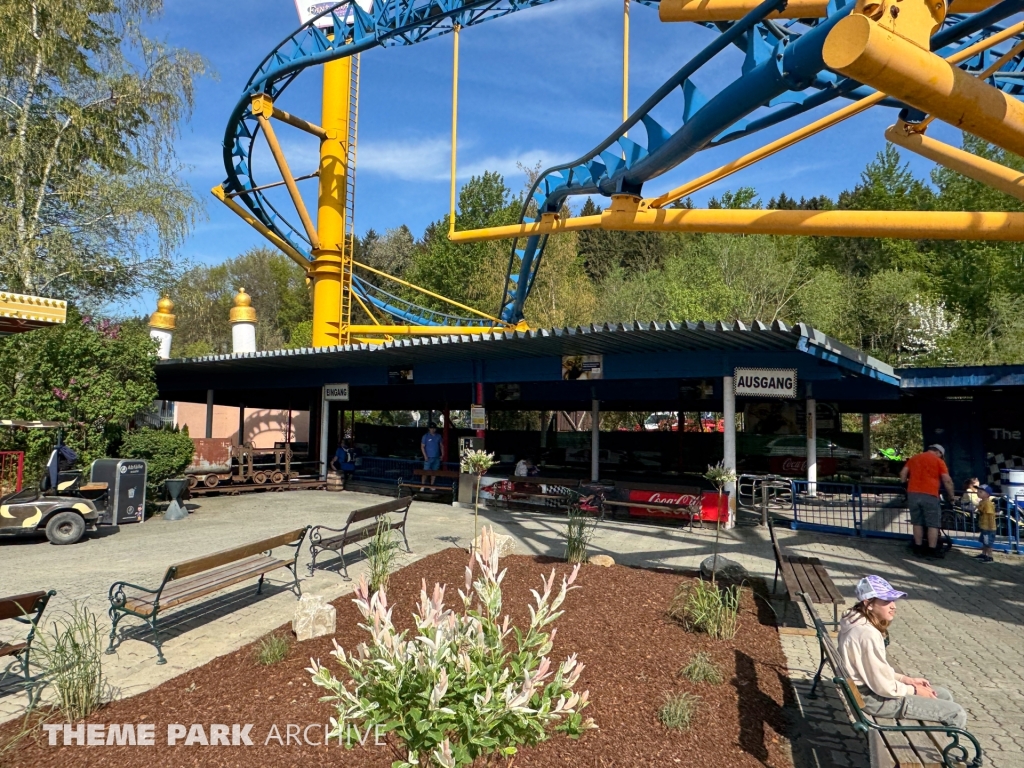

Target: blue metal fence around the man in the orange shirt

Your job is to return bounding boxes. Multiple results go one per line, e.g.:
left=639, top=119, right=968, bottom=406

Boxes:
left=792, top=480, right=1024, bottom=554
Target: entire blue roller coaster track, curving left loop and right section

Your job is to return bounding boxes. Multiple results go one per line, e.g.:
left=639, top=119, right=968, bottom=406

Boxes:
left=223, top=0, right=1024, bottom=326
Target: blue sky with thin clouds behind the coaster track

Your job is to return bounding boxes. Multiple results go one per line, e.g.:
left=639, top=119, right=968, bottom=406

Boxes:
left=125, top=0, right=959, bottom=311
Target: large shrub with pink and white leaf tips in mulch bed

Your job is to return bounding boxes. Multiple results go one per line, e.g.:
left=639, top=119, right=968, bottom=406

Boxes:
left=308, top=527, right=596, bottom=768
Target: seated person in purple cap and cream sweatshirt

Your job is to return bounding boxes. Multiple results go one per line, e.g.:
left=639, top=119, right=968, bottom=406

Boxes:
left=839, top=575, right=967, bottom=728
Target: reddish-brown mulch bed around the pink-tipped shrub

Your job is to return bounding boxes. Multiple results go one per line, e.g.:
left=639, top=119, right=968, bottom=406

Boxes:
left=0, top=549, right=793, bottom=768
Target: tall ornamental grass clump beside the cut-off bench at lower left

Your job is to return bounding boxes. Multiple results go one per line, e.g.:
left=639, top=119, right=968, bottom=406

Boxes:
left=32, top=603, right=111, bottom=723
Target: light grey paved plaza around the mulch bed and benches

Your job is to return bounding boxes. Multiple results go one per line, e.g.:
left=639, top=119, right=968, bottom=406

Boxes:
left=0, top=492, right=1024, bottom=768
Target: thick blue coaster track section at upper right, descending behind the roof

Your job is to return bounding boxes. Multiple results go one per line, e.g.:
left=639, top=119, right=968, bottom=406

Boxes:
left=499, top=0, right=1024, bottom=323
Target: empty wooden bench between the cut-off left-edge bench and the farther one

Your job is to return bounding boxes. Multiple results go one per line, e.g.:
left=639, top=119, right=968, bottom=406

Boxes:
left=106, top=525, right=309, bottom=664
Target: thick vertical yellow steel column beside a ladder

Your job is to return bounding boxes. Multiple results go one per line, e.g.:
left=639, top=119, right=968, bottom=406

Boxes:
left=309, top=57, right=352, bottom=347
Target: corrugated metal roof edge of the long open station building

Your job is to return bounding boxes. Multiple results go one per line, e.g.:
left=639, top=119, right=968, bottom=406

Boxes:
left=158, top=322, right=899, bottom=384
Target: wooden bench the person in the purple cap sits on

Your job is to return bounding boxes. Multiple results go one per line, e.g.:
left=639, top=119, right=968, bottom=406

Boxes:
left=800, top=593, right=982, bottom=768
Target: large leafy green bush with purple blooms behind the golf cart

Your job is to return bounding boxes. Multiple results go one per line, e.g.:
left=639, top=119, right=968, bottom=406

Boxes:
left=0, top=309, right=157, bottom=469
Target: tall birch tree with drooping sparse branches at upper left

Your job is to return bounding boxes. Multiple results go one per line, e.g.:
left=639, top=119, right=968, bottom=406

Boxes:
left=0, top=0, right=206, bottom=301
